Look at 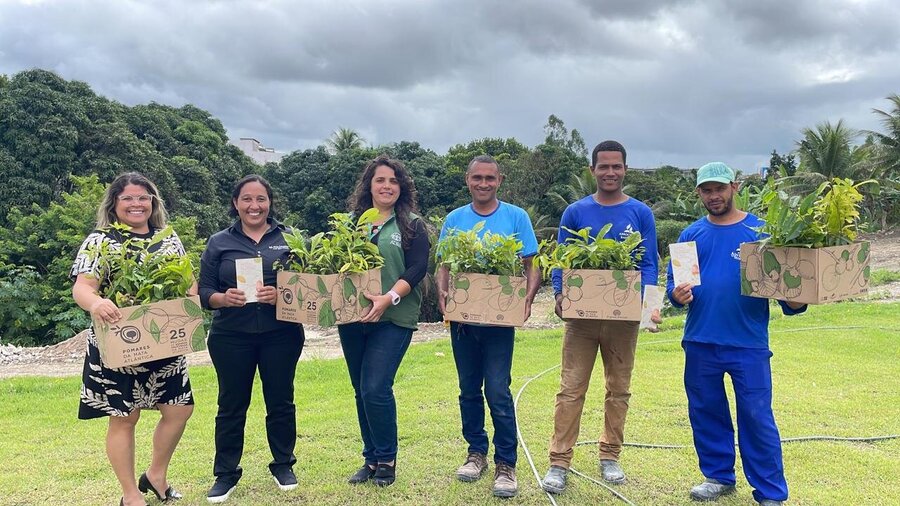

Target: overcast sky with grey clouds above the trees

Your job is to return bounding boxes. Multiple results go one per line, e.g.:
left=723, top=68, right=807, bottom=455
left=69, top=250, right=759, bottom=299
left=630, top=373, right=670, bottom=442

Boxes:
left=0, top=0, right=900, bottom=172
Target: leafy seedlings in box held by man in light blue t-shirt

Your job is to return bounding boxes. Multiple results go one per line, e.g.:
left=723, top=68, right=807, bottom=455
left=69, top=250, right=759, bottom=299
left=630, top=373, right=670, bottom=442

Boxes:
left=435, top=221, right=522, bottom=276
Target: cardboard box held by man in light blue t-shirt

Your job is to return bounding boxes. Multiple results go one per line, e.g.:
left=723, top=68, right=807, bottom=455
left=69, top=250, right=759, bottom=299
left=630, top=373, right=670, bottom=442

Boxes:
left=444, top=272, right=527, bottom=327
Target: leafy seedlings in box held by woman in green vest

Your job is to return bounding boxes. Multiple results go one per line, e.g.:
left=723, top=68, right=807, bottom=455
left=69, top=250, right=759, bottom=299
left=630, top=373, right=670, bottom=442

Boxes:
left=284, top=208, right=384, bottom=274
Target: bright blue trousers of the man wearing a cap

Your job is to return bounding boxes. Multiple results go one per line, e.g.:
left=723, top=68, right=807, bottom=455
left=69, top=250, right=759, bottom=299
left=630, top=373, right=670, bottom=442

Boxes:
left=682, top=341, right=788, bottom=501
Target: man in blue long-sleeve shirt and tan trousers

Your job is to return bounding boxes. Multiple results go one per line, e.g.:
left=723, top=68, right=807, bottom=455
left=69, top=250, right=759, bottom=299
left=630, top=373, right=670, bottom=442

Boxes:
left=542, top=141, right=659, bottom=493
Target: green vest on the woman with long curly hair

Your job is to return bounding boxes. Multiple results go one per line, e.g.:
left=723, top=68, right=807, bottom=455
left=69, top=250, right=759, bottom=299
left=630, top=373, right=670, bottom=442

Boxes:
left=378, top=214, right=422, bottom=330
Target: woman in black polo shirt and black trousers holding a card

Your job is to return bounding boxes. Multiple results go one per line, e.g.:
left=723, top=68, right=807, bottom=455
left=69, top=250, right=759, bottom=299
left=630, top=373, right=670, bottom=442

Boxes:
left=200, top=175, right=304, bottom=503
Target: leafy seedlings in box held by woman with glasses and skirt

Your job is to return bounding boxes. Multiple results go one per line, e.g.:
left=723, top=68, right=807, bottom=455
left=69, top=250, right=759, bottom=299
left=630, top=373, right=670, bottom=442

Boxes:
left=88, top=223, right=199, bottom=309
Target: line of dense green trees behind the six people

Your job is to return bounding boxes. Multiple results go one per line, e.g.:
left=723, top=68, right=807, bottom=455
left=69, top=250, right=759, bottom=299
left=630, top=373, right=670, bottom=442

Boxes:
left=0, top=69, right=900, bottom=345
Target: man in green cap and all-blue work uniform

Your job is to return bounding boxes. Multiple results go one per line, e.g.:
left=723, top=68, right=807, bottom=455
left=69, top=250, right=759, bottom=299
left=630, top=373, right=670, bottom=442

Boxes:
left=666, top=162, right=806, bottom=506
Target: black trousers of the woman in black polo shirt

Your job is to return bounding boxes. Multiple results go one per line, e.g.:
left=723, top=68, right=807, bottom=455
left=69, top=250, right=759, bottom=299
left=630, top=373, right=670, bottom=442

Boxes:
left=208, top=325, right=304, bottom=478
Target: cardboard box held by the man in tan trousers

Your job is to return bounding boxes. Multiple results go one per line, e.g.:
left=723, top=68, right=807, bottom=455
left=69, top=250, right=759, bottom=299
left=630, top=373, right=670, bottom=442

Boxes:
left=562, top=269, right=641, bottom=322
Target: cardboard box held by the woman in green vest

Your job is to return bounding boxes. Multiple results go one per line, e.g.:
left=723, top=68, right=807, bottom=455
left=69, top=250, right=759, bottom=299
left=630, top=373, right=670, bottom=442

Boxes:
left=275, top=269, right=381, bottom=327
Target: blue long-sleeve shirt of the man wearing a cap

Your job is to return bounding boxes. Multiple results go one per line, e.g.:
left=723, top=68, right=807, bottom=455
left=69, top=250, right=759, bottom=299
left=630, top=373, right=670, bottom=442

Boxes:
left=666, top=213, right=806, bottom=349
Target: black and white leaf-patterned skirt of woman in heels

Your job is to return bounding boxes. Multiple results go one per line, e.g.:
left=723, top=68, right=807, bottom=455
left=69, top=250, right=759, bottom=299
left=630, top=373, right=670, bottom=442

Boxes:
left=78, top=328, right=194, bottom=420
